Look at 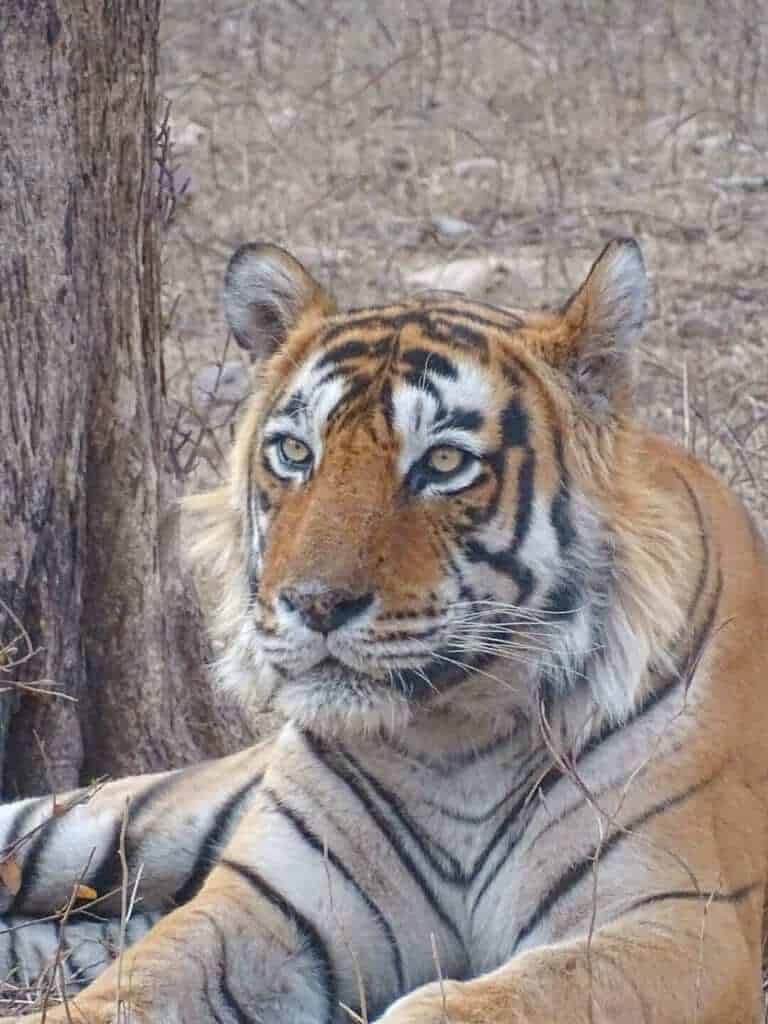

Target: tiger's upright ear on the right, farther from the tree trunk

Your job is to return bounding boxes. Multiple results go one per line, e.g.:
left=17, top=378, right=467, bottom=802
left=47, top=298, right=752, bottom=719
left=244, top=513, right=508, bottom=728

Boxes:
left=555, top=239, right=648, bottom=414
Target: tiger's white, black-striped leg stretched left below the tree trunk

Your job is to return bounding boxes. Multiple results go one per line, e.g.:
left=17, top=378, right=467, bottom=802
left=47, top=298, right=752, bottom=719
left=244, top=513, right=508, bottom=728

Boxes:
left=0, top=744, right=270, bottom=921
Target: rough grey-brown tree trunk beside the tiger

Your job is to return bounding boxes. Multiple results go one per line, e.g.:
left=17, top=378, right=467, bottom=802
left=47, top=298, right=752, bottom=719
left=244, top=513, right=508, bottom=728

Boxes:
left=0, top=0, right=253, bottom=796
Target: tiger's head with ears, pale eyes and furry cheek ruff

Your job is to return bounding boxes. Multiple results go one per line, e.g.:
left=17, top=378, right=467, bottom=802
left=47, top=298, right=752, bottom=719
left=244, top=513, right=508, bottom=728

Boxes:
left=190, top=240, right=692, bottom=731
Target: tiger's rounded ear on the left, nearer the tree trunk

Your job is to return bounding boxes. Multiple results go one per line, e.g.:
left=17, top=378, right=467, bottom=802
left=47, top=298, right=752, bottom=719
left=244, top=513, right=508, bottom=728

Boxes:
left=224, top=242, right=336, bottom=359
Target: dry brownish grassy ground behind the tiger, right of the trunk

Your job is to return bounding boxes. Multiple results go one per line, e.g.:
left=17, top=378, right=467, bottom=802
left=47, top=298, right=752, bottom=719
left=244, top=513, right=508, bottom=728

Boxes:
left=161, top=0, right=768, bottom=523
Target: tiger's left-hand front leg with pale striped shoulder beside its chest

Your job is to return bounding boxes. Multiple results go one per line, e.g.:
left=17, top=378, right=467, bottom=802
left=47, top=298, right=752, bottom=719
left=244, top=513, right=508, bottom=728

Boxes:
left=0, top=735, right=466, bottom=1024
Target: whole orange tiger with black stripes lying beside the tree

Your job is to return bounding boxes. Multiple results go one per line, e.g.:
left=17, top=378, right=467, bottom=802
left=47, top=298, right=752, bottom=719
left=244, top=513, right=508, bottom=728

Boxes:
left=0, top=239, right=768, bottom=1024
